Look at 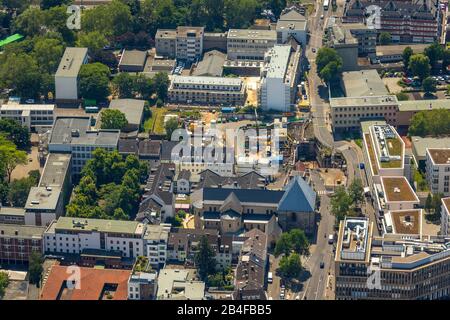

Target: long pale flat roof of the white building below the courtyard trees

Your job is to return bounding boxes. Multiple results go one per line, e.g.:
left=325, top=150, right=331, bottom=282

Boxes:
left=54, top=217, right=144, bottom=235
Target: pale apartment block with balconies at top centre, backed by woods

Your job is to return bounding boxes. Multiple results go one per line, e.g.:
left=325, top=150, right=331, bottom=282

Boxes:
left=155, top=26, right=204, bottom=61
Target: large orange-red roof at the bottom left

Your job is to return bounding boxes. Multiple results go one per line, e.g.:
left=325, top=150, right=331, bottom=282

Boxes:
left=40, top=265, right=131, bottom=300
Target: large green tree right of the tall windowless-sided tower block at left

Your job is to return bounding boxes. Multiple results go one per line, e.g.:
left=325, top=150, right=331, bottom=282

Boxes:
left=79, top=62, right=110, bottom=101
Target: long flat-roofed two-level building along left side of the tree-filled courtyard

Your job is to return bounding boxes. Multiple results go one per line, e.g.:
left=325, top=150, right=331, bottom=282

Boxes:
left=24, top=153, right=72, bottom=226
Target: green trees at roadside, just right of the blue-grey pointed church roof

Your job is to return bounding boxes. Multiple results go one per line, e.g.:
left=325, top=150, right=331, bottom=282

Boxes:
left=331, top=179, right=364, bottom=222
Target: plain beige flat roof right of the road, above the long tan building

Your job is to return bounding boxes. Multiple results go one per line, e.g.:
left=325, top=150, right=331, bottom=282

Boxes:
left=342, top=70, right=389, bottom=97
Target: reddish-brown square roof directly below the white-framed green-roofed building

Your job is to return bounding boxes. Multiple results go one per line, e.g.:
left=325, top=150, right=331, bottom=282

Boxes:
left=381, top=177, right=419, bottom=202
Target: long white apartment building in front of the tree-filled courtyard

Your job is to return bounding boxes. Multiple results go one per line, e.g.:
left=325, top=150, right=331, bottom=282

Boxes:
left=44, top=217, right=147, bottom=258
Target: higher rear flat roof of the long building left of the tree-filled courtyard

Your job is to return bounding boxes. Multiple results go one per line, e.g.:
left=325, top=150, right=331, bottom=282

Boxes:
left=39, top=153, right=72, bottom=187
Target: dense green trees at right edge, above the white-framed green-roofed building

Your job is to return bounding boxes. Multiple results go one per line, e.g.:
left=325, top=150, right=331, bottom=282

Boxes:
left=408, top=109, right=450, bottom=137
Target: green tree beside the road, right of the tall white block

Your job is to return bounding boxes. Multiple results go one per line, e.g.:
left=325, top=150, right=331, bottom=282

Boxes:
left=316, top=47, right=343, bottom=83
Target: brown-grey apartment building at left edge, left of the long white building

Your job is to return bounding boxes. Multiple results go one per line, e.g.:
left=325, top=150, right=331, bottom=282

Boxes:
left=0, top=224, right=45, bottom=265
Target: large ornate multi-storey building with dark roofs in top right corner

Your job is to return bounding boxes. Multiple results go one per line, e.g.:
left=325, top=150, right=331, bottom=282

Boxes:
left=342, top=0, right=442, bottom=43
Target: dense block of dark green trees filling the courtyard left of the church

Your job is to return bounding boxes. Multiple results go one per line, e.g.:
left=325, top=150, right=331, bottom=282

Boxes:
left=66, top=149, right=148, bottom=220
